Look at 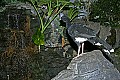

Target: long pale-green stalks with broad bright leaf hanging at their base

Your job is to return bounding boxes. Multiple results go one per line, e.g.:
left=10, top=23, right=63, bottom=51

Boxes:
left=31, top=0, right=68, bottom=46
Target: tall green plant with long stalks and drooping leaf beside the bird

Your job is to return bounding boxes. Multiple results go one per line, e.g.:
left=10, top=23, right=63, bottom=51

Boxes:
left=31, top=0, right=68, bottom=46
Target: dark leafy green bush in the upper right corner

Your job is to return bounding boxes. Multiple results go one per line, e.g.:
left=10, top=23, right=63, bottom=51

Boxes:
left=90, top=0, right=120, bottom=27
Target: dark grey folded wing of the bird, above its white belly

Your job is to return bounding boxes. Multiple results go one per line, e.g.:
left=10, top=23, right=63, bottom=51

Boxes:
left=68, top=24, right=96, bottom=38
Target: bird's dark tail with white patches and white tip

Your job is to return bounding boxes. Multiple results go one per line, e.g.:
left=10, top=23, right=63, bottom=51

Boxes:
left=88, top=37, right=114, bottom=53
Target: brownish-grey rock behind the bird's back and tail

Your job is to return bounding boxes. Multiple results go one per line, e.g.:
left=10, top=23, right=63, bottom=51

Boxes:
left=87, top=21, right=120, bottom=49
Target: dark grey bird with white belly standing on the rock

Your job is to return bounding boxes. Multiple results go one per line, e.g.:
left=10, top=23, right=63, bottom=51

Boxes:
left=61, top=15, right=114, bottom=57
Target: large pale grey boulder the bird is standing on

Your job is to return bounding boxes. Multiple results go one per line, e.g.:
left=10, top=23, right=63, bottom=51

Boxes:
left=51, top=50, right=120, bottom=80
